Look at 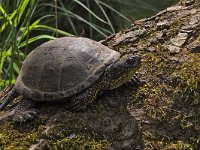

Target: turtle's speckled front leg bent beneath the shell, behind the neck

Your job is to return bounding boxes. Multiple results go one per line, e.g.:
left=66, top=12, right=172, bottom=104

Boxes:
left=69, top=85, right=99, bottom=111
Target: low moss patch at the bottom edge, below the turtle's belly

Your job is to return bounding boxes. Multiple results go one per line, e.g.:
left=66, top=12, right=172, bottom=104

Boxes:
left=45, top=126, right=110, bottom=150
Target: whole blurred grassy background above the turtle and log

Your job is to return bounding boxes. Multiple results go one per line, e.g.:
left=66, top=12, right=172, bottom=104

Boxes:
left=0, top=0, right=177, bottom=90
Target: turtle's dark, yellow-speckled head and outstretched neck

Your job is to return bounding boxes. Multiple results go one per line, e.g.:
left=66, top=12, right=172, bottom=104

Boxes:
left=102, top=55, right=141, bottom=90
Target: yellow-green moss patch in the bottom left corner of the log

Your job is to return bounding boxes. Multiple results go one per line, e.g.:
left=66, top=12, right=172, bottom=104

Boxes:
left=0, top=116, right=47, bottom=150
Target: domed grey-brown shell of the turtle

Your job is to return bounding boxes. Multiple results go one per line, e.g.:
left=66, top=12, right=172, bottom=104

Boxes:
left=15, top=37, right=120, bottom=101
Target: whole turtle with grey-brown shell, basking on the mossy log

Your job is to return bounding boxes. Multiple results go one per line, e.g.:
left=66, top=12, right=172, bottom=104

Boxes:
left=0, top=37, right=141, bottom=122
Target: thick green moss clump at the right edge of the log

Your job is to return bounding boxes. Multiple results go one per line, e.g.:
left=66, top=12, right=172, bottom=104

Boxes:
left=173, top=52, right=200, bottom=105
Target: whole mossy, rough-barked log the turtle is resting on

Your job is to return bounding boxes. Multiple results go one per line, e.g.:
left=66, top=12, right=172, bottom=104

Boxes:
left=0, top=0, right=200, bottom=150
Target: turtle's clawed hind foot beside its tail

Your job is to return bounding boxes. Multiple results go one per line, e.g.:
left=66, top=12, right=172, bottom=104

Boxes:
left=13, top=98, right=37, bottom=123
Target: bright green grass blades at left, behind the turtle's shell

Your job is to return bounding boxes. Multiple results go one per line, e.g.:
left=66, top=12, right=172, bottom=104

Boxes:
left=0, top=0, right=70, bottom=86
